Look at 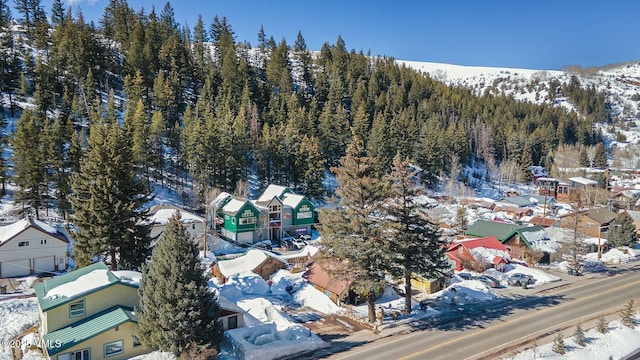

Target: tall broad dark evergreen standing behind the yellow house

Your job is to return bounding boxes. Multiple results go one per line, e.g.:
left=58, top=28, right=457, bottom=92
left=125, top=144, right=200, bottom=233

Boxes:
left=71, top=122, right=151, bottom=270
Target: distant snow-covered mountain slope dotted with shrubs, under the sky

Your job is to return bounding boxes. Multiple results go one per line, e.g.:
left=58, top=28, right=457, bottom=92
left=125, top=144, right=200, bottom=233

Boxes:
left=397, top=60, right=640, bottom=167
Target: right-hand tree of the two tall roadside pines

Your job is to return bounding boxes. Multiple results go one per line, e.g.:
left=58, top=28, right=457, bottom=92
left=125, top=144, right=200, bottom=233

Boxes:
left=385, top=153, right=450, bottom=314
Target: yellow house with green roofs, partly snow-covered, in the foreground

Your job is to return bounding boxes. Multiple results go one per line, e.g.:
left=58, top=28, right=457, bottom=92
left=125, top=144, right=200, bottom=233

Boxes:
left=34, top=262, right=152, bottom=360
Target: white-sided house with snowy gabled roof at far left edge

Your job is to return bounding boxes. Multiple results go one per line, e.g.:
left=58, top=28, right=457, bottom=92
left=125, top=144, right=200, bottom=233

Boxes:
left=0, top=218, right=69, bottom=278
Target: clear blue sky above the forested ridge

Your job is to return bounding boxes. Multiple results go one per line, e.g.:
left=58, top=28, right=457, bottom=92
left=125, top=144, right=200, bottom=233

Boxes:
left=32, top=0, right=640, bottom=69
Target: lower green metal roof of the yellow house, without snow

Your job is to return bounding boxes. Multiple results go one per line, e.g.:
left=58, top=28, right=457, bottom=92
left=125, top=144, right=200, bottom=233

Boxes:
left=43, top=306, right=138, bottom=356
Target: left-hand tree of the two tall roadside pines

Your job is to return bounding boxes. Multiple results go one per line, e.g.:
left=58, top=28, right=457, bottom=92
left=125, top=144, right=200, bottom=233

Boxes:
left=320, top=137, right=388, bottom=323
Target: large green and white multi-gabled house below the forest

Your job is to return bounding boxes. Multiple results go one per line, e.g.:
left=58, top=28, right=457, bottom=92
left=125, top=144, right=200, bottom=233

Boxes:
left=214, top=184, right=315, bottom=244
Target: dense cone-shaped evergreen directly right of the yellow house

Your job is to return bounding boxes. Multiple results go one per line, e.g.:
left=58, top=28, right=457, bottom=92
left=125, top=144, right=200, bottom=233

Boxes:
left=136, top=212, right=222, bottom=355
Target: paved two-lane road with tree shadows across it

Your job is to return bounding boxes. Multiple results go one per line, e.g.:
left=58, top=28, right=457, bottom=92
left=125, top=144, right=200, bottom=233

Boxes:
left=328, top=271, right=640, bottom=360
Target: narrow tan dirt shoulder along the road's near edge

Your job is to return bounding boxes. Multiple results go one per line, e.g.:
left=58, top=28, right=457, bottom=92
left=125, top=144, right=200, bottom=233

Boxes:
left=465, top=310, right=616, bottom=360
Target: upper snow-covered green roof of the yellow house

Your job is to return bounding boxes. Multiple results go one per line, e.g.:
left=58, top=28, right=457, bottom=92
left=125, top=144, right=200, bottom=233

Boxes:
left=33, top=262, right=138, bottom=312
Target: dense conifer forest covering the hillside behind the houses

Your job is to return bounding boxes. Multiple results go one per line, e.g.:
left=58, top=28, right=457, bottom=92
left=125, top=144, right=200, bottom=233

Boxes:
left=0, top=0, right=610, bottom=216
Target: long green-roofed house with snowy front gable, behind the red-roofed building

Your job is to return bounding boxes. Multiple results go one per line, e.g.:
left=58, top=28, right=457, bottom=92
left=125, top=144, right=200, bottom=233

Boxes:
left=465, top=220, right=559, bottom=264
